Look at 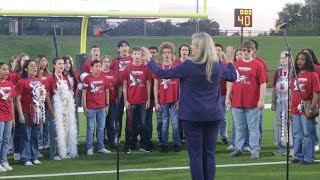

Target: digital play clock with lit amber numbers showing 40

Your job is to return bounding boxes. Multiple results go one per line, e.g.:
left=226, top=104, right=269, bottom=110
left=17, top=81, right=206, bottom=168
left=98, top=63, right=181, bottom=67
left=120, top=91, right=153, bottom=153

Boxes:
left=234, top=9, right=252, bottom=27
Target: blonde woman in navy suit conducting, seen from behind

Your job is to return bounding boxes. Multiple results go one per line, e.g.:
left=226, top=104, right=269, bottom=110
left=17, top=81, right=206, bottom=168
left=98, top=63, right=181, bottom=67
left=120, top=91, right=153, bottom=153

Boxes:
left=143, top=33, right=237, bottom=180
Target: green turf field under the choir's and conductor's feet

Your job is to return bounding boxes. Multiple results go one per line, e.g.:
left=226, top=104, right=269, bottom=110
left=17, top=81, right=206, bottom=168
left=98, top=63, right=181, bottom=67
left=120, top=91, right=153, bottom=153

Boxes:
left=0, top=110, right=320, bottom=180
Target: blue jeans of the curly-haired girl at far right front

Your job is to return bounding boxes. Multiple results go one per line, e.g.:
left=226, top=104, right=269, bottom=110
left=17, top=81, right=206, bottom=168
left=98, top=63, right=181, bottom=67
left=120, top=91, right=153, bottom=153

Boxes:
left=292, top=114, right=316, bottom=162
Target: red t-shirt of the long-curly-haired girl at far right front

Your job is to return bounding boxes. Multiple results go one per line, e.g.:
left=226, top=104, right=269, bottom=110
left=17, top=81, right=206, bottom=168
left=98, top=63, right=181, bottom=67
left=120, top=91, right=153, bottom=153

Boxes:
left=290, top=71, right=320, bottom=115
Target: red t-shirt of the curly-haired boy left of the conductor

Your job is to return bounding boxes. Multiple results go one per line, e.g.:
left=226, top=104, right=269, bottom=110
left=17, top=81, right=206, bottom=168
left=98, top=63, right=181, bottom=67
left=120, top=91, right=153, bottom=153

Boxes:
left=154, top=62, right=179, bottom=104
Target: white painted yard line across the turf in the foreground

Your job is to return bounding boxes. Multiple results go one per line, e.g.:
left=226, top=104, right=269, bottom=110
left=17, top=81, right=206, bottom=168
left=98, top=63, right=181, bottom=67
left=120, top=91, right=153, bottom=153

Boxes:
left=0, top=160, right=320, bottom=179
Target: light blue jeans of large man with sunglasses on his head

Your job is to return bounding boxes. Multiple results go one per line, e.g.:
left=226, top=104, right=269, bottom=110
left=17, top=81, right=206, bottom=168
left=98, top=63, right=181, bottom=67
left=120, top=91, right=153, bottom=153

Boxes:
left=232, top=108, right=261, bottom=154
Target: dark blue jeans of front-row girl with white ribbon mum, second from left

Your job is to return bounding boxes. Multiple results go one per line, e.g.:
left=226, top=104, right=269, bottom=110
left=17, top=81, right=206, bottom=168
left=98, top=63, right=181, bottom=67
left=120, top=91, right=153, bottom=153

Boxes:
left=19, top=113, right=40, bottom=164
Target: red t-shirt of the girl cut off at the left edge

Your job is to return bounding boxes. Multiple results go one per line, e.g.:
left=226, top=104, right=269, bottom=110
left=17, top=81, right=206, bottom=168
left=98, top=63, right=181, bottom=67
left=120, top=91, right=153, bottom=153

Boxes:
left=0, top=80, right=15, bottom=122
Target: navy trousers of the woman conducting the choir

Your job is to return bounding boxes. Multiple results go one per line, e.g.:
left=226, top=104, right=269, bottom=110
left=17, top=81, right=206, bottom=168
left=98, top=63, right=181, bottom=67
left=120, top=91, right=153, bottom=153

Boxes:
left=181, top=120, right=220, bottom=180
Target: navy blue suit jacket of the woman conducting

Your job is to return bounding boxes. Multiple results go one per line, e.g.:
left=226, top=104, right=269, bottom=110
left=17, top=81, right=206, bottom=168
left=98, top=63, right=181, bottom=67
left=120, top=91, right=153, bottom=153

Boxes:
left=148, top=60, right=237, bottom=121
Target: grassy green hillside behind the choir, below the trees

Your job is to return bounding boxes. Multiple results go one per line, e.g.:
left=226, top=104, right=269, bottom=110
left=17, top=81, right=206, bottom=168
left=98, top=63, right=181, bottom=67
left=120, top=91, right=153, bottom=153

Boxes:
left=0, top=35, right=320, bottom=87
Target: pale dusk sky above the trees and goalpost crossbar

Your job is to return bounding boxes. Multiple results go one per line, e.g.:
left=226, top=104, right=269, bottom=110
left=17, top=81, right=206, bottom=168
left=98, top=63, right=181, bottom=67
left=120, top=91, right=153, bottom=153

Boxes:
left=0, top=0, right=304, bottom=31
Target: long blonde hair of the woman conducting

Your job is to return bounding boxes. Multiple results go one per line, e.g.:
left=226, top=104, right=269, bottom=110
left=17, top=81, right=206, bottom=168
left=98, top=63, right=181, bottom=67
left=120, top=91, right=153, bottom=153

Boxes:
left=192, top=33, right=218, bottom=82
